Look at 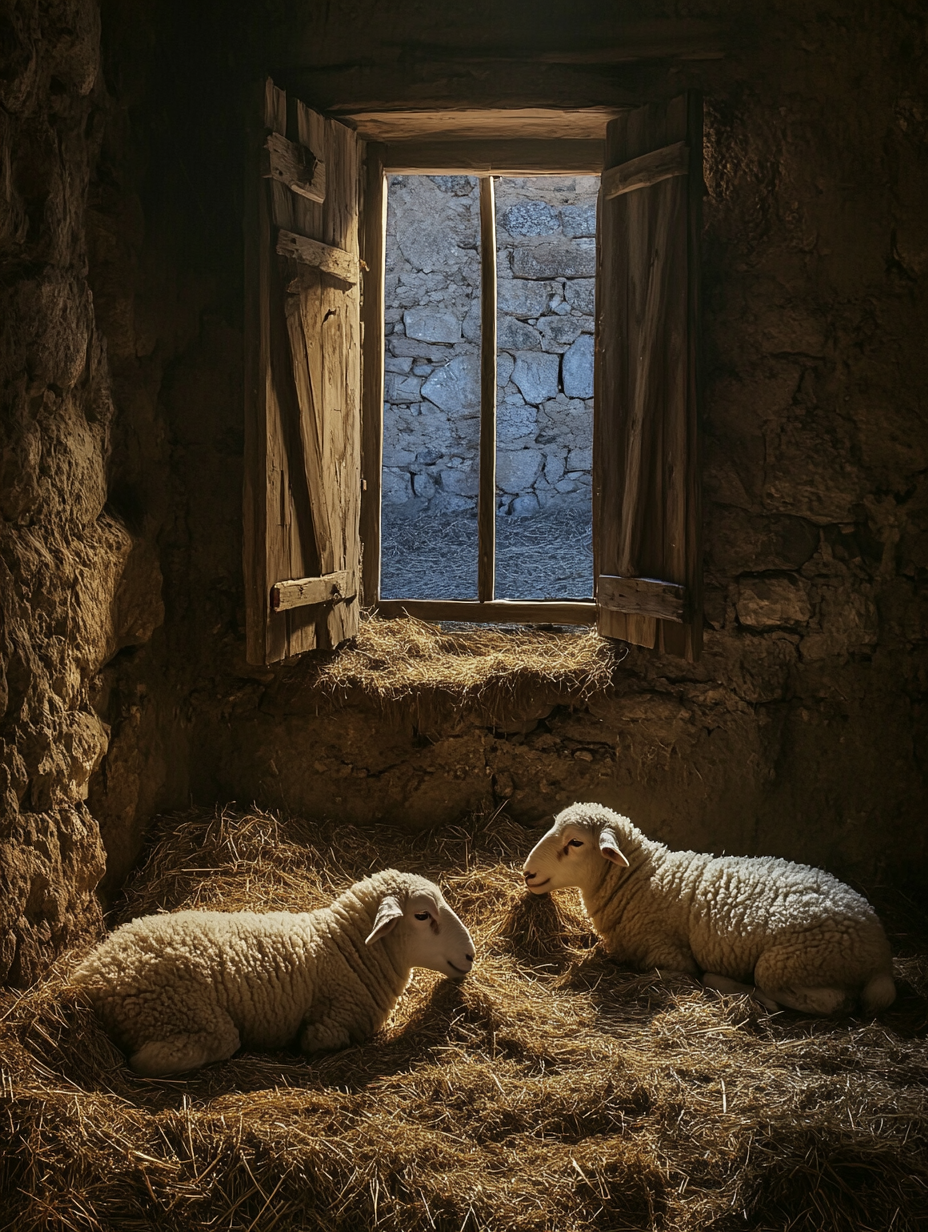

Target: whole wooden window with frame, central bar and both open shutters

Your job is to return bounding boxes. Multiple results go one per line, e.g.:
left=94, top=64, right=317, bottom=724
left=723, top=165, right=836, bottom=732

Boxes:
left=245, top=83, right=702, bottom=663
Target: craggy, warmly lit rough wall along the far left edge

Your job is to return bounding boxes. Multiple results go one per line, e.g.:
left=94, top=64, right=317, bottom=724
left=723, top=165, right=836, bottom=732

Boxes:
left=0, top=0, right=158, bottom=981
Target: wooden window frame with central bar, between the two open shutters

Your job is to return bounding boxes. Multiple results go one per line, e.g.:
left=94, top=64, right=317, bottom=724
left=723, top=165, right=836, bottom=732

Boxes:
left=361, top=137, right=605, bottom=626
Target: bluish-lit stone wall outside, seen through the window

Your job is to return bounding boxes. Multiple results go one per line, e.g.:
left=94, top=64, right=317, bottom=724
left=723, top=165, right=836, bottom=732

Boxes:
left=383, top=175, right=599, bottom=517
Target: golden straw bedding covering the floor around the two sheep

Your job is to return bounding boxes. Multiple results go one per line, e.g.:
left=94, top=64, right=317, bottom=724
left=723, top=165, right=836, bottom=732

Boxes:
left=0, top=812, right=928, bottom=1232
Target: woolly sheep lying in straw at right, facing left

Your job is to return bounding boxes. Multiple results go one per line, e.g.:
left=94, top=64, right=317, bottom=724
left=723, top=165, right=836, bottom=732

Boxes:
left=524, top=804, right=896, bottom=1014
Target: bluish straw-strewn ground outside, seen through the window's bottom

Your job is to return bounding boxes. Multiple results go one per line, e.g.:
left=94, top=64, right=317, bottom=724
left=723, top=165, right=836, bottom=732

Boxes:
left=381, top=506, right=593, bottom=599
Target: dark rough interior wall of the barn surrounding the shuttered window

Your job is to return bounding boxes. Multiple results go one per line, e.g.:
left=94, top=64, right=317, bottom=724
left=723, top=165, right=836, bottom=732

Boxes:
left=0, top=0, right=928, bottom=982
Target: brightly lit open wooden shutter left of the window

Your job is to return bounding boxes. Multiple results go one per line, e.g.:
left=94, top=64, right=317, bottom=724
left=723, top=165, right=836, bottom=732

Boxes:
left=244, top=80, right=361, bottom=663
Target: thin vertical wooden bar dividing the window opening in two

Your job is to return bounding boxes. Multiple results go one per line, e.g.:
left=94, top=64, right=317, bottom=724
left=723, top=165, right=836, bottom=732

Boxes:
left=477, top=175, right=497, bottom=602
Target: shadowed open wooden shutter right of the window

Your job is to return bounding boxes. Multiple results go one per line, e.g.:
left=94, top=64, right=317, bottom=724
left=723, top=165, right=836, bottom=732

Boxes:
left=594, top=91, right=702, bottom=659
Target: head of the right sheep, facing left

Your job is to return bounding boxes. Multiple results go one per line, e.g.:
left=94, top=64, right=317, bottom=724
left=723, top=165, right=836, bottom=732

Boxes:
left=523, top=804, right=633, bottom=894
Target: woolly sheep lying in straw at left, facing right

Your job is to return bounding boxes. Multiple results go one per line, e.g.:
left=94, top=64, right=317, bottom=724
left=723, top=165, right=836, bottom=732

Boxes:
left=73, top=869, right=473, bottom=1078
